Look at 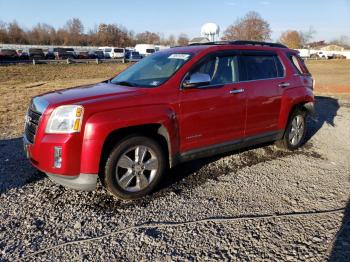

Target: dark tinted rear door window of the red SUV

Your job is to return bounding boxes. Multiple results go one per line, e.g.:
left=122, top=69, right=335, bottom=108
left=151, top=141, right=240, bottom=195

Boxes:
left=243, top=55, right=284, bottom=80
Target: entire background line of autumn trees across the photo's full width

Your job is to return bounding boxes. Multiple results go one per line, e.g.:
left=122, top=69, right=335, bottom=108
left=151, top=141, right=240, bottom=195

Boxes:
left=0, top=11, right=349, bottom=49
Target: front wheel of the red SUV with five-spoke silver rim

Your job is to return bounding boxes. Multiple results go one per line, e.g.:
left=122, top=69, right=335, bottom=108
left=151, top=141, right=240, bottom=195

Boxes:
left=103, top=135, right=166, bottom=200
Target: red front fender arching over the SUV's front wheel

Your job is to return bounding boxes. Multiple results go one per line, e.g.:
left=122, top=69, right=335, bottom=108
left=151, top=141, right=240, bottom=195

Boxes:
left=80, top=105, right=179, bottom=174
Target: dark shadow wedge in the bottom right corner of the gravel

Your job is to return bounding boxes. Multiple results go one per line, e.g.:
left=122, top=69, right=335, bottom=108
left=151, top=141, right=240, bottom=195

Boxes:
left=328, top=199, right=350, bottom=262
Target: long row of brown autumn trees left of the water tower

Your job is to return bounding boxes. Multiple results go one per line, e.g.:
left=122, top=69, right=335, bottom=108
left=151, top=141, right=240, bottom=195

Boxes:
left=0, top=18, right=189, bottom=47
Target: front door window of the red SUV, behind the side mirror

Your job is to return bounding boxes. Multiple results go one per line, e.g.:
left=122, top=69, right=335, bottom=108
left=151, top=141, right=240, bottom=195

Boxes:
left=191, top=56, right=238, bottom=85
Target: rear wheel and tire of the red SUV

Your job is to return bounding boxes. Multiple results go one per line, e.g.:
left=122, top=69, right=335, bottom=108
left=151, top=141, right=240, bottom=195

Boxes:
left=276, top=109, right=307, bottom=150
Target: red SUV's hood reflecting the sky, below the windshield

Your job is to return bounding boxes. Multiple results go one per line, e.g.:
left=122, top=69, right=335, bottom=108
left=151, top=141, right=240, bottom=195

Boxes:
left=39, top=83, right=141, bottom=105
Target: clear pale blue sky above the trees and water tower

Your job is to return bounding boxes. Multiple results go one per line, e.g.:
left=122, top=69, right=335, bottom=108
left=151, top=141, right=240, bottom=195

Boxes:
left=0, top=0, right=350, bottom=41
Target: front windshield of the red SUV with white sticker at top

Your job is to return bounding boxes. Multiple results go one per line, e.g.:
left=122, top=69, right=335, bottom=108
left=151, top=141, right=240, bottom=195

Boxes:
left=111, top=52, right=192, bottom=87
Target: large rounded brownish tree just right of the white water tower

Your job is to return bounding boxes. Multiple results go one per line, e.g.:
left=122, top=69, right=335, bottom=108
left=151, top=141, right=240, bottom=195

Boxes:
left=222, top=11, right=271, bottom=41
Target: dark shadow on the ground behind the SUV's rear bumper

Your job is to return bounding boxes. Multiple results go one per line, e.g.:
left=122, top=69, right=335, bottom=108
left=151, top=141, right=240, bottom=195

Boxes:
left=306, top=96, right=340, bottom=142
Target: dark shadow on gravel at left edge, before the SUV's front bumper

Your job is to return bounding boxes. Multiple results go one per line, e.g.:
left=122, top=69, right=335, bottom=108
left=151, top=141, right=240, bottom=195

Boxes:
left=0, top=138, right=44, bottom=194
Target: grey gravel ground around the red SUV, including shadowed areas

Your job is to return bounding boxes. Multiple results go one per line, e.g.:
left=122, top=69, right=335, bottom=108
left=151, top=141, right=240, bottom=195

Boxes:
left=0, top=97, right=350, bottom=261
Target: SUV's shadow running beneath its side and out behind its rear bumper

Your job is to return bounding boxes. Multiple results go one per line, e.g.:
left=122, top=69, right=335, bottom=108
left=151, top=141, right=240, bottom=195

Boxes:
left=158, top=96, right=340, bottom=193
